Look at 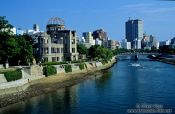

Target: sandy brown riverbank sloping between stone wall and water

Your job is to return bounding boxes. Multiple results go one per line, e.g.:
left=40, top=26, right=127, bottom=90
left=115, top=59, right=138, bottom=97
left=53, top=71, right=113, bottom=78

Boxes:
left=0, top=60, right=116, bottom=108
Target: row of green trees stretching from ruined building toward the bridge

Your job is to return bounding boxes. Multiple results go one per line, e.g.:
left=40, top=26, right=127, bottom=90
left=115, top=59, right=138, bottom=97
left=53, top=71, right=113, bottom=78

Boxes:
left=77, top=44, right=163, bottom=61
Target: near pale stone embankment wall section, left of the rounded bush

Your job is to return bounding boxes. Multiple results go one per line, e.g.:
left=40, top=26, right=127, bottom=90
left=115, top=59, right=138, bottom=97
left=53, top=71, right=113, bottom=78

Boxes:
left=0, top=65, right=45, bottom=95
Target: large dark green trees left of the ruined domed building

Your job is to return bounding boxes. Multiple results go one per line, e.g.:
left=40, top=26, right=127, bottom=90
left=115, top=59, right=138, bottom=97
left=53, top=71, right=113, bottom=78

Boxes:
left=0, top=16, right=34, bottom=65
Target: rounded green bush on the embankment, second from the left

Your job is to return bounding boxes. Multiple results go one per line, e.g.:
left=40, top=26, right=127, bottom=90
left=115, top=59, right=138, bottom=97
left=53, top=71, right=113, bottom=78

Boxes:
left=43, top=65, right=57, bottom=76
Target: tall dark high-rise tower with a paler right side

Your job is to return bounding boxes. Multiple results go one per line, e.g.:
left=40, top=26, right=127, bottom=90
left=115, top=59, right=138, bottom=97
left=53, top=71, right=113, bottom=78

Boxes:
left=125, top=19, right=143, bottom=48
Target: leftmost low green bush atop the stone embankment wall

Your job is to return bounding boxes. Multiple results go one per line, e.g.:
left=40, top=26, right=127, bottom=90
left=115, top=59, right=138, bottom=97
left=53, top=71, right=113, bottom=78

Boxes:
left=4, top=69, right=22, bottom=82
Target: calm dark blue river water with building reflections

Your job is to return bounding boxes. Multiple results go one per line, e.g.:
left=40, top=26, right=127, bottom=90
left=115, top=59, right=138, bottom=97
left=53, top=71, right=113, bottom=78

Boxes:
left=0, top=56, right=175, bottom=114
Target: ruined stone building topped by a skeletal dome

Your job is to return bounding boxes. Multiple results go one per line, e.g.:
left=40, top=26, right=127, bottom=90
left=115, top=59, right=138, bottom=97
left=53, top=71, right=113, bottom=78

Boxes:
left=35, top=18, right=78, bottom=62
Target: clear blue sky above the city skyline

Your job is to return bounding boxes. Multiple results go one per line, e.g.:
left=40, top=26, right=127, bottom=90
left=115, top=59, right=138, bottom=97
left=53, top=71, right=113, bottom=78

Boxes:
left=0, top=0, right=175, bottom=41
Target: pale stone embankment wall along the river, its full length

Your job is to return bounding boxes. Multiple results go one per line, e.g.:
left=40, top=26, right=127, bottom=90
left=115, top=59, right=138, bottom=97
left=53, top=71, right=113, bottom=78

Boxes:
left=0, top=57, right=115, bottom=95
